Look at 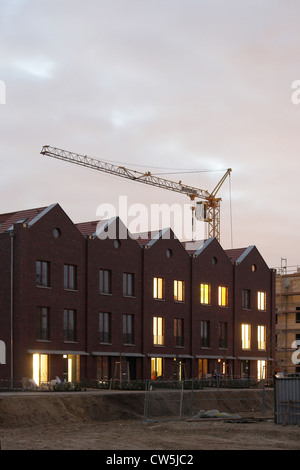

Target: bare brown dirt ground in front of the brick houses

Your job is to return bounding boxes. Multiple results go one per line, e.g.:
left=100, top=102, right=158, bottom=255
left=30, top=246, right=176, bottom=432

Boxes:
left=0, top=391, right=300, bottom=451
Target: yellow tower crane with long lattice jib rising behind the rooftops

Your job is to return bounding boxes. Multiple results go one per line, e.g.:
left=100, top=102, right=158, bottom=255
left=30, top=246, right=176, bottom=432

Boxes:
left=40, top=145, right=232, bottom=242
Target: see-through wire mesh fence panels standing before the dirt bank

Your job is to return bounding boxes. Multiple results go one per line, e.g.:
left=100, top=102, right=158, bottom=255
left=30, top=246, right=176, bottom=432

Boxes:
left=143, top=379, right=274, bottom=421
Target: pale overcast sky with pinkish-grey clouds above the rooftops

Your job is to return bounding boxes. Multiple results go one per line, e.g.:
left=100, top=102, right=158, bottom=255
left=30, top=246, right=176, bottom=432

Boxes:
left=0, top=0, right=300, bottom=267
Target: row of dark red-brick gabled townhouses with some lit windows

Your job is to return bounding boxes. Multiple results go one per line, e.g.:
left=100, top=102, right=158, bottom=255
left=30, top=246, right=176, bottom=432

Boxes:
left=0, top=204, right=275, bottom=386
